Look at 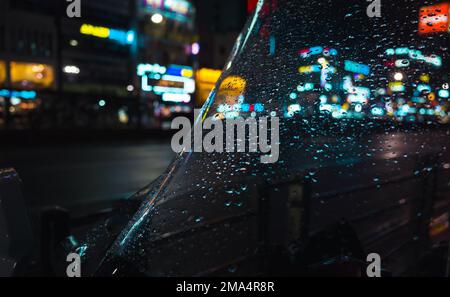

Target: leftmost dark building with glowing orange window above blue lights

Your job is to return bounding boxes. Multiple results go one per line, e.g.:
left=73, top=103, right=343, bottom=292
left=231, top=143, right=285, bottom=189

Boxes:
left=0, top=0, right=57, bottom=129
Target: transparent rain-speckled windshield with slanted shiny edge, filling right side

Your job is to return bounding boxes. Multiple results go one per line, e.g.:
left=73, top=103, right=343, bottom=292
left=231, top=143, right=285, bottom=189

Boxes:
left=0, top=0, right=450, bottom=276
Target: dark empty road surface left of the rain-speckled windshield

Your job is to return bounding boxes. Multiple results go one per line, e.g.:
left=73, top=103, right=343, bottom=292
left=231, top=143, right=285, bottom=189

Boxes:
left=0, top=141, right=174, bottom=210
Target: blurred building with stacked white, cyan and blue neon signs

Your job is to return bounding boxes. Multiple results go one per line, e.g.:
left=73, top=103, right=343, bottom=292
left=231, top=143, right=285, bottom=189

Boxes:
left=137, top=0, right=196, bottom=129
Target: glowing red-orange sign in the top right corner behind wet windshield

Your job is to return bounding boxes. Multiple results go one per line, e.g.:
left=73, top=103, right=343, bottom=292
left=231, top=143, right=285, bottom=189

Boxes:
left=419, top=3, right=450, bottom=34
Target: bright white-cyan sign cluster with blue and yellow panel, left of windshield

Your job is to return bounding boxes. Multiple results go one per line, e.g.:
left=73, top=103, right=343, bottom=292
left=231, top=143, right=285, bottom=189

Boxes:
left=137, top=64, right=195, bottom=103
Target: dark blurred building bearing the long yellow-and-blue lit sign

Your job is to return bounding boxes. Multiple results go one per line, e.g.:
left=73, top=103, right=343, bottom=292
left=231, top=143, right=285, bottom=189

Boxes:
left=59, top=0, right=140, bottom=129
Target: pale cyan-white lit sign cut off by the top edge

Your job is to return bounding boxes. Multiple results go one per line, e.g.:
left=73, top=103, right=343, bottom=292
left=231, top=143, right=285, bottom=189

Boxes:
left=141, top=0, right=194, bottom=22
